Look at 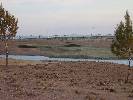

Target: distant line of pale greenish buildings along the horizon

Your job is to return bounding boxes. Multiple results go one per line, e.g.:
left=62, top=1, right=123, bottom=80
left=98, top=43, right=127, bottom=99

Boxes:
left=14, top=34, right=114, bottom=40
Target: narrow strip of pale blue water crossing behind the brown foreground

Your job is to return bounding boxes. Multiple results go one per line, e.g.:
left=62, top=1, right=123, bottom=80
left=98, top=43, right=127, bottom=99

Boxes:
left=0, top=55, right=133, bottom=66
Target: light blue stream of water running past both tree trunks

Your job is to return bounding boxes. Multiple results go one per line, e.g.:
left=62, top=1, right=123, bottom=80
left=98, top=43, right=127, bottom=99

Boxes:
left=0, top=55, right=133, bottom=66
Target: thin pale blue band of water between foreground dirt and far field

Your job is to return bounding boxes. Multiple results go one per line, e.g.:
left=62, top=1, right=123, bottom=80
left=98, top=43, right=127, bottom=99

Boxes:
left=0, top=55, right=133, bottom=66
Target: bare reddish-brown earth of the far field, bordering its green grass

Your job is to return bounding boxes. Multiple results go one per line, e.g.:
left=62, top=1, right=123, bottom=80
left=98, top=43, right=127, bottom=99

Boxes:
left=0, top=39, right=111, bottom=56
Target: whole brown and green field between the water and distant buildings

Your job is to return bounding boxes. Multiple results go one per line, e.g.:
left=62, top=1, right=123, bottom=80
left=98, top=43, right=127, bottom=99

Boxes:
left=0, top=39, right=114, bottom=58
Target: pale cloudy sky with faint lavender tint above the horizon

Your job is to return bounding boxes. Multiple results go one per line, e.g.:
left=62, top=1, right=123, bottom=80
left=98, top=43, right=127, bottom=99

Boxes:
left=0, top=0, right=133, bottom=36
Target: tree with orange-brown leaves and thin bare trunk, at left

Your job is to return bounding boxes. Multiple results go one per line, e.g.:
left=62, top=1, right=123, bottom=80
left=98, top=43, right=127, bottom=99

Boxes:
left=0, top=4, right=18, bottom=66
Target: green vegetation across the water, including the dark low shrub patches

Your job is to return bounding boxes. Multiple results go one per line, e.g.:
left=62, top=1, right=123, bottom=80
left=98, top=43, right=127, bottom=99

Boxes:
left=17, top=43, right=115, bottom=58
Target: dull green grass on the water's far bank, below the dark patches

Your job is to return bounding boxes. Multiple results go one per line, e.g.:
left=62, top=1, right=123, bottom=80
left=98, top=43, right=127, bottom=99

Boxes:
left=38, top=45, right=114, bottom=57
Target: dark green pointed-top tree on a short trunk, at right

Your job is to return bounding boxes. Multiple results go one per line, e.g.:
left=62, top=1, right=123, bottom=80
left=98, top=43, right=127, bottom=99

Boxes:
left=111, top=11, right=133, bottom=68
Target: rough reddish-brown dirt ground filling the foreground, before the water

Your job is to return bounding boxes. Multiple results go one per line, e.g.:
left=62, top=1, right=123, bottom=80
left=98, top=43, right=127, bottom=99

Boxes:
left=0, top=62, right=133, bottom=100
